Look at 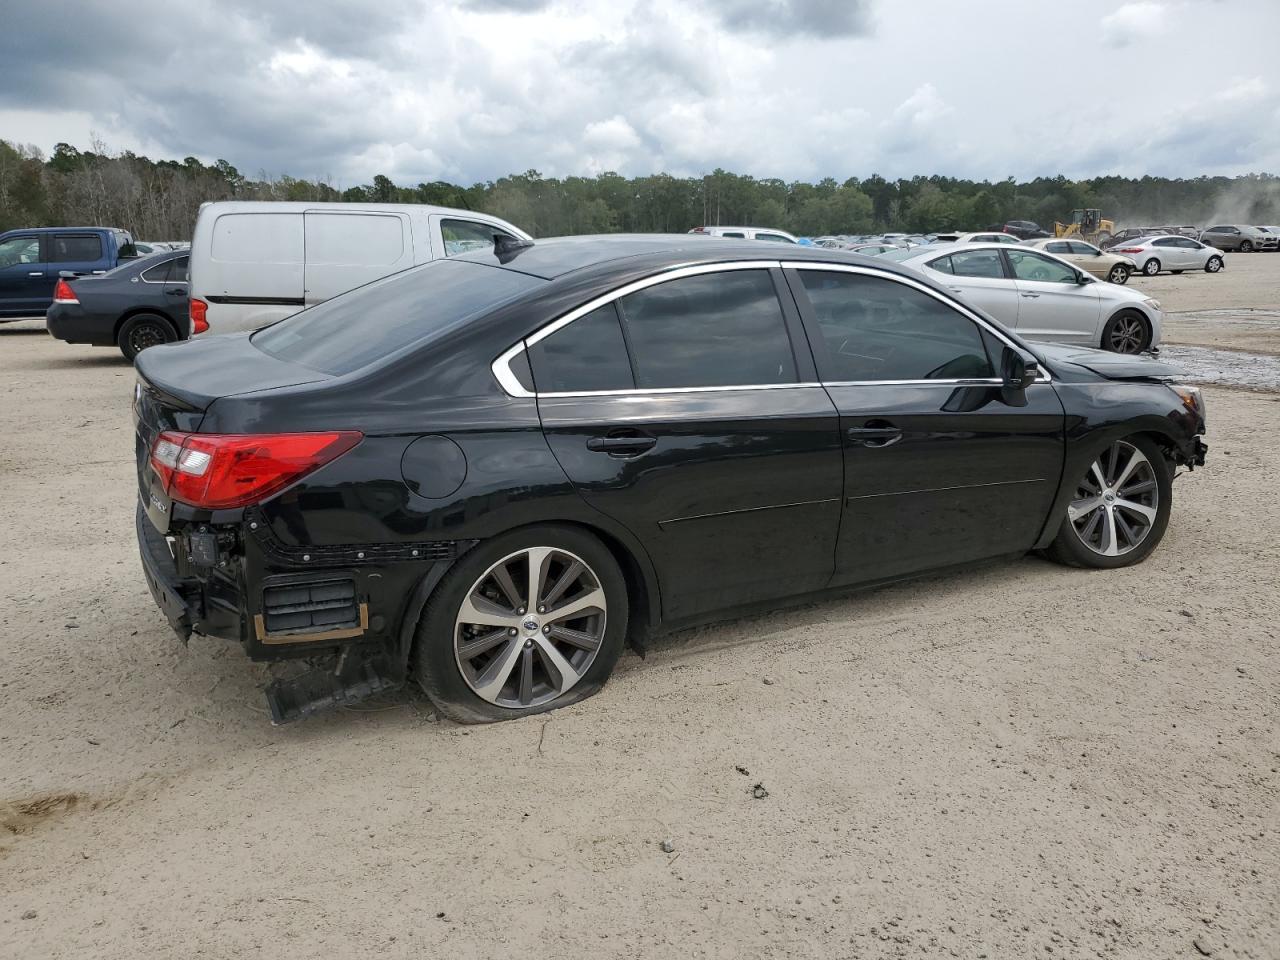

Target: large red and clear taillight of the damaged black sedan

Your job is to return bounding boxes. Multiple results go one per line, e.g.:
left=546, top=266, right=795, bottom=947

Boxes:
left=151, top=430, right=364, bottom=509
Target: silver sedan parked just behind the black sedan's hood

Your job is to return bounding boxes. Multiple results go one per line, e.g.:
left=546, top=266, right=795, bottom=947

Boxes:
left=883, top=243, right=1164, bottom=353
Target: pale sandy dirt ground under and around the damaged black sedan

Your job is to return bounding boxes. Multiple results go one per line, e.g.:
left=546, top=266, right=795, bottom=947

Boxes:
left=0, top=255, right=1280, bottom=960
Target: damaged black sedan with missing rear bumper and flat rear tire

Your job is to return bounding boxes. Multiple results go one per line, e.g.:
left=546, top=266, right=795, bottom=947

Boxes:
left=134, top=236, right=1204, bottom=722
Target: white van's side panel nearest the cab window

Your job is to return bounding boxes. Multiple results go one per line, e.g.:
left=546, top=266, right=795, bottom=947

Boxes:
left=303, top=210, right=413, bottom=307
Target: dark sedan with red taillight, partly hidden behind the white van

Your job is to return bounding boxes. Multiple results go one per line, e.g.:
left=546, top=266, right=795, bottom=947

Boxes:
left=45, top=251, right=191, bottom=360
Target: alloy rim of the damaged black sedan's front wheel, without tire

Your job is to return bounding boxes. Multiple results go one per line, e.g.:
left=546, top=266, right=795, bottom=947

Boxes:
left=1066, top=440, right=1160, bottom=557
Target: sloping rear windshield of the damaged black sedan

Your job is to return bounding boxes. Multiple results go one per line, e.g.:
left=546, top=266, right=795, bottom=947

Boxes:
left=252, top=260, right=543, bottom=376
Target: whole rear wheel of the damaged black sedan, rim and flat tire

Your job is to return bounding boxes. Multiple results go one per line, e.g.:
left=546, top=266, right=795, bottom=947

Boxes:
left=413, top=525, right=628, bottom=723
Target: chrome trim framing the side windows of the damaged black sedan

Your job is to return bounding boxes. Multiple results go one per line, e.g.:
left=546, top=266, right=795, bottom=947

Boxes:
left=490, top=260, right=1053, bottom=399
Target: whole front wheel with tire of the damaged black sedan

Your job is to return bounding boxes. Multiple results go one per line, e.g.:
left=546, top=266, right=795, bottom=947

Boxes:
left=1047, top=436, right=1172, bottom=570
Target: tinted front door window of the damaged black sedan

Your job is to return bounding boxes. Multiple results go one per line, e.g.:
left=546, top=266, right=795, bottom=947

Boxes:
left=799, top=270, right=992, bottom=381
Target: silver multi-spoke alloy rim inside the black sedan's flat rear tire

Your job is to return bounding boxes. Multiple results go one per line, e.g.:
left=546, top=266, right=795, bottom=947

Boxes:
left=453, top=547, right=608, bottom=709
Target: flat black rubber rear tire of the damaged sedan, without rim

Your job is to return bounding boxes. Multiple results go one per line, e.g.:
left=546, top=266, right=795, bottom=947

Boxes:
left=411, top=524, right=630, bottom=723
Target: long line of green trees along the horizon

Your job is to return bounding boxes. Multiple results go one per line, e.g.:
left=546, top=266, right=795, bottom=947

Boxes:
left=0, top=140, right=1280, bottom=241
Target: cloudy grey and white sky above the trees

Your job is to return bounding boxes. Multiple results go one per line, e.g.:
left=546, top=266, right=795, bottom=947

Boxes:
left=0, top=0, right=1280, bottom=187
